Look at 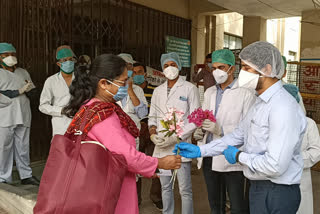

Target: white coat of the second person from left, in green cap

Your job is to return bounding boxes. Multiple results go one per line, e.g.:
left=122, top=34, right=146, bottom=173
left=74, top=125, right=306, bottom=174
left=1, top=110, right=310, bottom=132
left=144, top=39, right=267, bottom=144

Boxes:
left=39, top=72, right=74, bottom=136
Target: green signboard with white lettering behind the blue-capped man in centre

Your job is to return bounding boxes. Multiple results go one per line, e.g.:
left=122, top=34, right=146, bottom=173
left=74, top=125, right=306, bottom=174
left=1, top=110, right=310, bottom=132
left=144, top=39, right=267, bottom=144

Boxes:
left=165, top=36, right=191, bottom=68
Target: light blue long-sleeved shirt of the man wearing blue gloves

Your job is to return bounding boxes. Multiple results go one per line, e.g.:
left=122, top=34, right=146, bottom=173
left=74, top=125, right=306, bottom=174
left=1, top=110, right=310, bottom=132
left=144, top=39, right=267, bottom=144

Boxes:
left=200, top=81, right=307, bottom=185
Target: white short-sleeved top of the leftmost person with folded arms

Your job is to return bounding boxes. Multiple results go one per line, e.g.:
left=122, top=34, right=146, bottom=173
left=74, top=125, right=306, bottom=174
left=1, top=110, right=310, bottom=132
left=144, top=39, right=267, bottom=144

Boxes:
left=0, top=68, right=31, bottom=127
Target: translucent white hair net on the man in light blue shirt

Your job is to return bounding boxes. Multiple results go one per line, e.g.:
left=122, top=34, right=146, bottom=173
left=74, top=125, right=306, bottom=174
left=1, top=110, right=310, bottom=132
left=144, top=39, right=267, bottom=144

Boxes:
left=239, top=42, right=284, bottom=79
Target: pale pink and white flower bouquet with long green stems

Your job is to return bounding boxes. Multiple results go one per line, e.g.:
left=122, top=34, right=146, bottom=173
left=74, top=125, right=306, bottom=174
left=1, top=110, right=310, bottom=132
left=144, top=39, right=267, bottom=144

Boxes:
left=160, top=108, right=184, bottom=189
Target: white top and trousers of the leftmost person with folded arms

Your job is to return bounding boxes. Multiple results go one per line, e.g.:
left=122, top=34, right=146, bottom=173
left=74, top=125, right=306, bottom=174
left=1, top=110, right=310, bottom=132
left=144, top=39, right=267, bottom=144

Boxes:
left=0, top=68, right=32, bottom=182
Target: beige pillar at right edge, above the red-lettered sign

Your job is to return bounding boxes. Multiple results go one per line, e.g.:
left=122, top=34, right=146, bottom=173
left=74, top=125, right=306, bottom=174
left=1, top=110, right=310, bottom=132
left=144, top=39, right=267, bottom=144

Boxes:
left=300, top=10, right=320, bottom=62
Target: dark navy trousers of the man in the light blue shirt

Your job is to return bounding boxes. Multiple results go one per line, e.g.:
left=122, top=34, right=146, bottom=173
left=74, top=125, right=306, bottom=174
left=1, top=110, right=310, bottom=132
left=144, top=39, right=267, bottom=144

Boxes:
left=249, top=181, right=301, bottom=214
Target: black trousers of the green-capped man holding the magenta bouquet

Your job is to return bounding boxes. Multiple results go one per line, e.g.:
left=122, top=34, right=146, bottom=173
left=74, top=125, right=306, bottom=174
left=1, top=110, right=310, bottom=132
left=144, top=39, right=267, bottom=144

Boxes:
left=203, top=157, right=249, bottom=214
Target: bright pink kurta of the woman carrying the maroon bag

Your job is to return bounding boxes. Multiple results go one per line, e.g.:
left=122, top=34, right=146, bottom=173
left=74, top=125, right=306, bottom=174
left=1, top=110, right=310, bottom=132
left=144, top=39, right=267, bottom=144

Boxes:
left=87, top=100, right=158, bottom=214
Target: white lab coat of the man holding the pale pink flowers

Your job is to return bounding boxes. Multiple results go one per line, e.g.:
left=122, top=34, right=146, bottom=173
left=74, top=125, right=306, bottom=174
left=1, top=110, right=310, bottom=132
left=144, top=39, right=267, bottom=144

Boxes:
left=149, top=77, right=200, bottom=162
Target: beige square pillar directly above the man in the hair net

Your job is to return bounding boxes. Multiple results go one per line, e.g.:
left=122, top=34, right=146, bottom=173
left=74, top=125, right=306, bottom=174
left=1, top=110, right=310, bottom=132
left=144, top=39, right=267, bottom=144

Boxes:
left=242, top=16, right=267, bottom=47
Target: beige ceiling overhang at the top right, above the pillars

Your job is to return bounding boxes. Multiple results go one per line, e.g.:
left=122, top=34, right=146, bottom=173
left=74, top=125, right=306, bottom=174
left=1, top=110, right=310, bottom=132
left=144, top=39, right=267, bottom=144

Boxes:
left=208, top=0, right=317, bottom=19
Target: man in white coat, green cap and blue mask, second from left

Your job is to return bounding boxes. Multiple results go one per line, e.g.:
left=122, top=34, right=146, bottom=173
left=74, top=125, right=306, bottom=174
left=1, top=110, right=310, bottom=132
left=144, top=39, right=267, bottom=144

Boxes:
left=39, top=45, right=76, bottom=136
